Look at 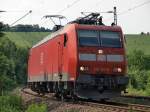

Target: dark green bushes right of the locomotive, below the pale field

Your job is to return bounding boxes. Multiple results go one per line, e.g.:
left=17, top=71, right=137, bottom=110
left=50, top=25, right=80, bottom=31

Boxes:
left=128, top=50, right=150, bottom=95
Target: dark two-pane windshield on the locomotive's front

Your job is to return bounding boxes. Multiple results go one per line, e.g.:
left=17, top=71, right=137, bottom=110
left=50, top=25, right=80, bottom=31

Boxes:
left=78, top=30, right=122, bottom=48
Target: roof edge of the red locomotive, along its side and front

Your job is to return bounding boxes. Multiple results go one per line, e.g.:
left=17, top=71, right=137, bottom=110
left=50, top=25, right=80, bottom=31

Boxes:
left=32, top=23, right=121, bottom=48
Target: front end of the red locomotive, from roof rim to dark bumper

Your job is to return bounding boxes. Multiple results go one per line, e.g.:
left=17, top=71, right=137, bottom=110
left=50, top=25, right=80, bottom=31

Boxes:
left=74, top=25, right=128, bottom=99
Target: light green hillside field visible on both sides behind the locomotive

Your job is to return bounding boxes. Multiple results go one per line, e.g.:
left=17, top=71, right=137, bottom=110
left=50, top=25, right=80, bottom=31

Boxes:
left=5, top=32, right=150, bottom=55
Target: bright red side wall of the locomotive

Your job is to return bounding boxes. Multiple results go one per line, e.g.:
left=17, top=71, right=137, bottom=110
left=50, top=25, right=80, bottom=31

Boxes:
left=28, top=24, right=77, bottom=80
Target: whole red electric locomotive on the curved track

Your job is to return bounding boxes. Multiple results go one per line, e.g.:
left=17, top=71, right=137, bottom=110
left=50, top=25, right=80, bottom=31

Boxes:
left=28, top=13, right=128, bottom=100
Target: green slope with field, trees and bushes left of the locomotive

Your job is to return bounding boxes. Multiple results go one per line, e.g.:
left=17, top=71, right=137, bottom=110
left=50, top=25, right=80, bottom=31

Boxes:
left=0, top=32, right=49, bottom=112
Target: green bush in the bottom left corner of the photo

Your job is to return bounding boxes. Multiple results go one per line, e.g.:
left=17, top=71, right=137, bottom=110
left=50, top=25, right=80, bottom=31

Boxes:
left=0, top=95, right=22, bottom=112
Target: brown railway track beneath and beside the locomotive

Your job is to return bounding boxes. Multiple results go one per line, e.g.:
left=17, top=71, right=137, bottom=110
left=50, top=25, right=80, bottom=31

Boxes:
left=21, top=88, right=150, bottom=112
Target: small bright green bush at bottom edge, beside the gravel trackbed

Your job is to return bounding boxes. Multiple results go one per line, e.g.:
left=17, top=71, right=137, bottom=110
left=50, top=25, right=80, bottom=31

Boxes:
left=26, top=104, right=48, bottom=112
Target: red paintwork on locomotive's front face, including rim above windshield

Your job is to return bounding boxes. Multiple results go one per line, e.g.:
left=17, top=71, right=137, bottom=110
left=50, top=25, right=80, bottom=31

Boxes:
left=77, top=25, right=127, bottom=75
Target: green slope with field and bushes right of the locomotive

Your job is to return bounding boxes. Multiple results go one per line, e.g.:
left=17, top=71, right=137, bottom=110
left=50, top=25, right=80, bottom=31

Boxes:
left=126, top=35, right=150, bottom=96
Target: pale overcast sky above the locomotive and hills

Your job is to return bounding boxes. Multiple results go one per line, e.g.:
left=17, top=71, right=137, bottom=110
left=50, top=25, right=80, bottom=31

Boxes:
left=0, top=0, right=150, bottom=34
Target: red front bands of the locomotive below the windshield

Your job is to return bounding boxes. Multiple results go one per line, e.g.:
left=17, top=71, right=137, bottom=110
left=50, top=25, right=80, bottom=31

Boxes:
left=79, top=47, right=126, bottom=75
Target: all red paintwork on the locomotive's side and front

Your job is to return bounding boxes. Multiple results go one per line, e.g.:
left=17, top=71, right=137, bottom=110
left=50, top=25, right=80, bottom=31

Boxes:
left=28, top=24, right=126, bottom=79
